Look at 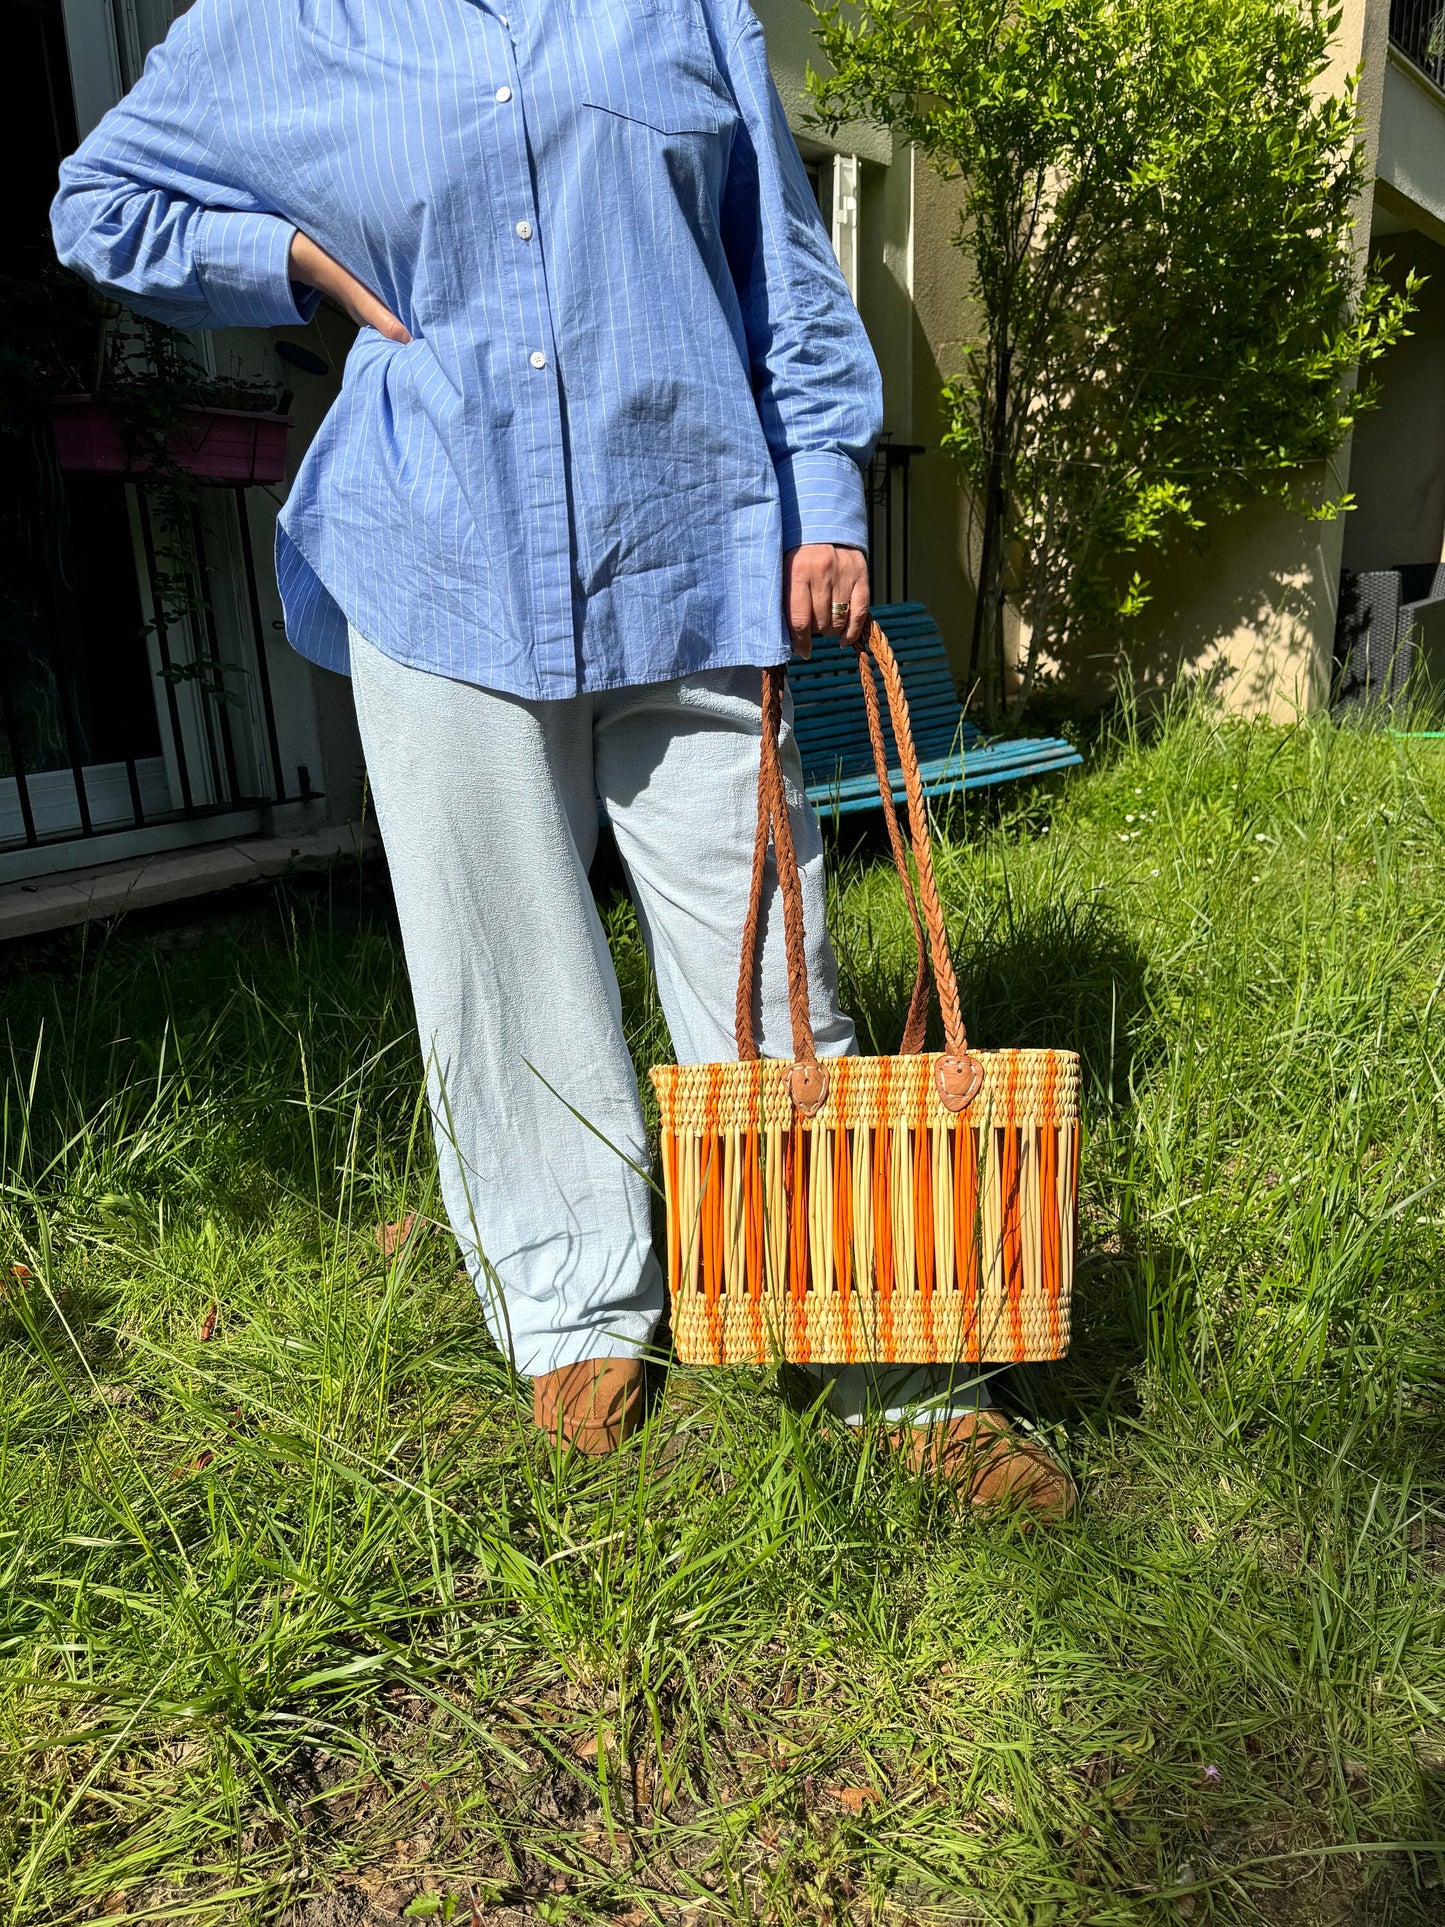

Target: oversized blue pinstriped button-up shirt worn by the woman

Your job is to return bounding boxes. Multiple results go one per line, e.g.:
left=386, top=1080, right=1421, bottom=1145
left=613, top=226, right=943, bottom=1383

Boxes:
left=52, top=0, right=880, bottom=698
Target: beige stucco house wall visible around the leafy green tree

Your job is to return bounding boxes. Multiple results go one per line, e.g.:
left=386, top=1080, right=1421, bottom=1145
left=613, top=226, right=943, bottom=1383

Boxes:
left=759, top=0, right=1445, bottom=719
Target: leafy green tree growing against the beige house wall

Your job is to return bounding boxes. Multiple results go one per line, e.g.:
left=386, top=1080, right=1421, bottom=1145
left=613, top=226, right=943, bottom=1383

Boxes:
left=811, top=0, right=1410, bottom=713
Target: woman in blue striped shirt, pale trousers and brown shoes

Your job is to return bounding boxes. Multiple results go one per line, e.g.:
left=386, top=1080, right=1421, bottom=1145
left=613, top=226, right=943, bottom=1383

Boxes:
left=54, top=0, right=1067, bottom=1511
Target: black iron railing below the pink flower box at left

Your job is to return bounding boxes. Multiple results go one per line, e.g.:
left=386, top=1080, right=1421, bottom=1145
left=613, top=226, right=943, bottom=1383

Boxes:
left=0, top=430, right=287, bottom=850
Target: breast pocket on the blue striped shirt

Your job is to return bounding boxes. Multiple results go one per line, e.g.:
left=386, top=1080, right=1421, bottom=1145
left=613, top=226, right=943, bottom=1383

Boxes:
left=572, top=0, right=738, bottom=135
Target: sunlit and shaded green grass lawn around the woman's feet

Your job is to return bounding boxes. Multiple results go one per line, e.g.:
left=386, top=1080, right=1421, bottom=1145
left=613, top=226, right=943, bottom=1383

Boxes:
left=0, top=711, right=1445, bottom=1927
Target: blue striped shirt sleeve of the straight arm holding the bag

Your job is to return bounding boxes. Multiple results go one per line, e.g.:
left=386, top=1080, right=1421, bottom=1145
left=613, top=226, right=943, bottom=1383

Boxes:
left=723, top=17, right=882, bottom=549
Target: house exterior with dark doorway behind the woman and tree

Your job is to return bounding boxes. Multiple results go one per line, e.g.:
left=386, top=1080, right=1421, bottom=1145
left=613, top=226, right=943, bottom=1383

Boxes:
left=0, top=0, right=1445, bottom=935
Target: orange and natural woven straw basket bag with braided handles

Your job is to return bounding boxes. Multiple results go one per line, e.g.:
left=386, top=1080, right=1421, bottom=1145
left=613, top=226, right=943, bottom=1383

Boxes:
left=651, top=622, right=1079, bottom=1364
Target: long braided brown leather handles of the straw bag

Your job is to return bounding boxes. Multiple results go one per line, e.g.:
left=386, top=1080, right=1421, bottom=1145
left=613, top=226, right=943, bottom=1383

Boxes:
left=734, top=622, right=983, bottom=1112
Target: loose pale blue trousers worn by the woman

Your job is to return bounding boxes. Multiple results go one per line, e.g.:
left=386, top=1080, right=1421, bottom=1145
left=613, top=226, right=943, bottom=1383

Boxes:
left=351, top=630, right=979, bottom=1416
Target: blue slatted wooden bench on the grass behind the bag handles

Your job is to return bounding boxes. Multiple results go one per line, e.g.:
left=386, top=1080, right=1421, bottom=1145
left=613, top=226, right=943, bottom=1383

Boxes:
left=788, top=603, right=1083, bottom=817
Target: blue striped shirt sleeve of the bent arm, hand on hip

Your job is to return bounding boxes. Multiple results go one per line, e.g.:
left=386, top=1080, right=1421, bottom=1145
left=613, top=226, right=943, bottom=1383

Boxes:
left=50, top=8, right=318, bottom=328
